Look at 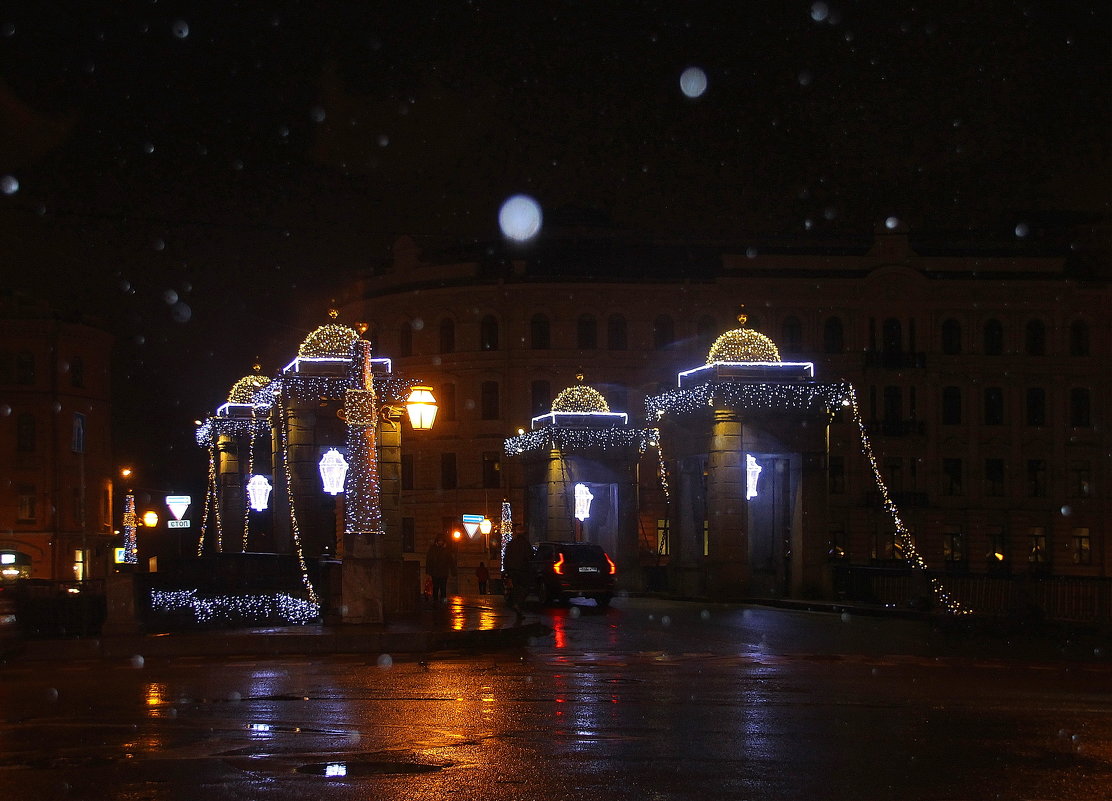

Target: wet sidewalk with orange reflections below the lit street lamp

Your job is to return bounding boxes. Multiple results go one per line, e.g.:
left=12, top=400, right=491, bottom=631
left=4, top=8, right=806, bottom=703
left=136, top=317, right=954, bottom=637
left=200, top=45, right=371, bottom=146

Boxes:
left=2, top=595, right=549, bottom=662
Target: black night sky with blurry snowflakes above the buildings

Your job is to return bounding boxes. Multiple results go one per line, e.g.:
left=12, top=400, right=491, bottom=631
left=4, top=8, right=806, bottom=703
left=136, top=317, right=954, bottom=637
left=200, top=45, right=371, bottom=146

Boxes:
left=0, top=0, right=1112, bottom=481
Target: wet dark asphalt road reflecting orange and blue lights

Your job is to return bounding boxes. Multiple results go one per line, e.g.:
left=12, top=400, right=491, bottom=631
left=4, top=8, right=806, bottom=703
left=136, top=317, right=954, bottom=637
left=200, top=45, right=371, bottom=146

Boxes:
left=0, top=599, right=1112, bottom=801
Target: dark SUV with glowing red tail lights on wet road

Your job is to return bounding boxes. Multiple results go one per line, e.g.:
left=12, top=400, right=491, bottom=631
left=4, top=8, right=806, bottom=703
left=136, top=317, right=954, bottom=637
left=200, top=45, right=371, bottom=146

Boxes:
left=533, top=542, right=617, bottom=606
